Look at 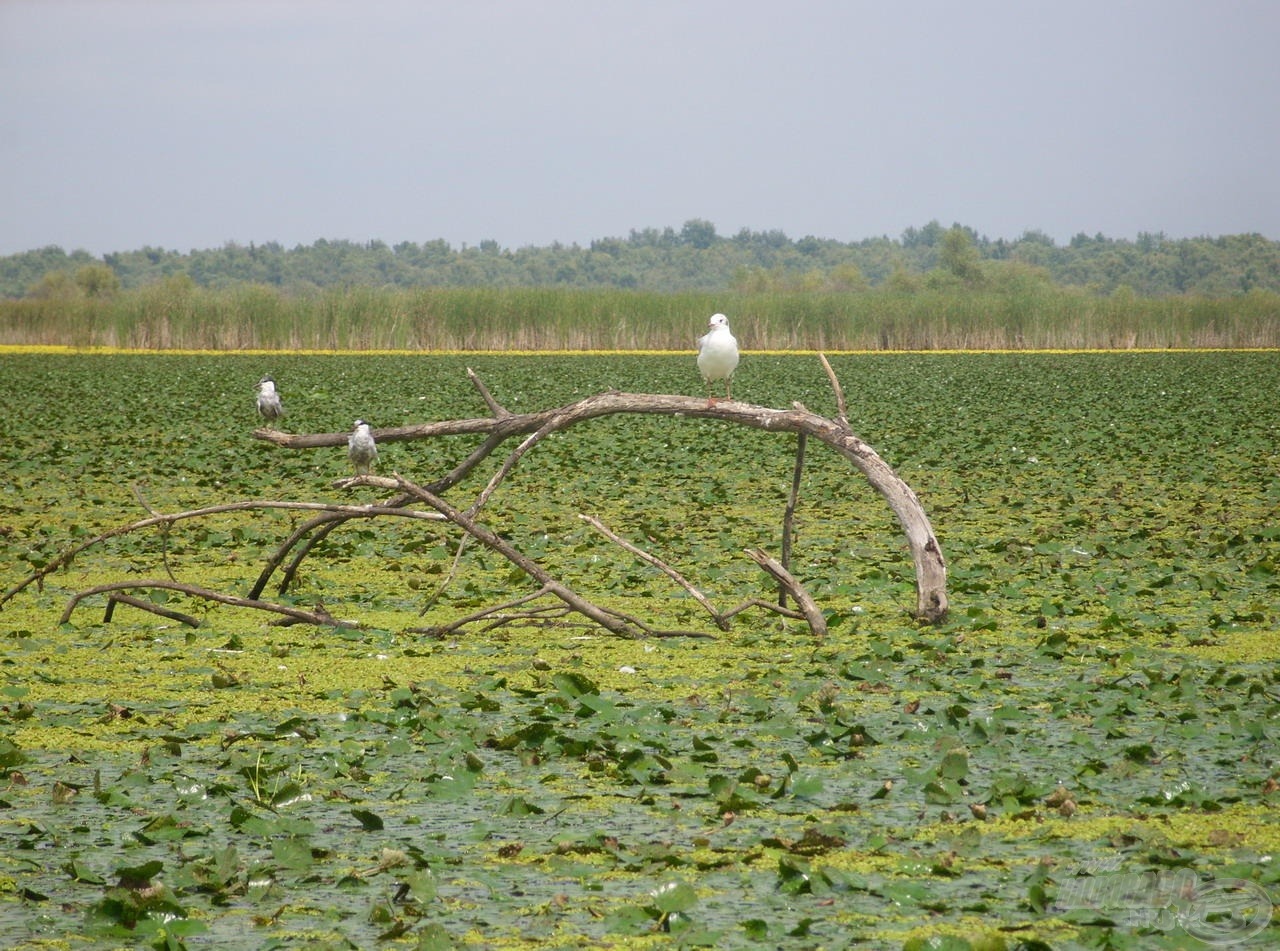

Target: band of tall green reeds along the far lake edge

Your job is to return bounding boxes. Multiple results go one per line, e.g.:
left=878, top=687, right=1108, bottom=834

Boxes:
left=0, top=283, right=1280, bottom=351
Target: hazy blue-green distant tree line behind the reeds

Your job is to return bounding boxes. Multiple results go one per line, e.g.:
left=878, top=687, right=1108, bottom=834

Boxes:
left=0, top=219, right=1280, bottom=300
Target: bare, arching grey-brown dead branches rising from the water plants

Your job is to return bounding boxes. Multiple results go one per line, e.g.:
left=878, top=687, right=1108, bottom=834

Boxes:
left=0, top=357, right=947, bottom=637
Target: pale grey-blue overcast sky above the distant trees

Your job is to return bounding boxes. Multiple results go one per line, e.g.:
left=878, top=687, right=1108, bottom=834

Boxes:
left=0, top=0, right=1280, bottom=255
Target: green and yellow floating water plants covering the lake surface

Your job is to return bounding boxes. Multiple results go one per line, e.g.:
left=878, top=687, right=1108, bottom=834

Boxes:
left=0, top=353, right=1280, bottom=950
